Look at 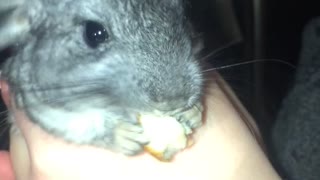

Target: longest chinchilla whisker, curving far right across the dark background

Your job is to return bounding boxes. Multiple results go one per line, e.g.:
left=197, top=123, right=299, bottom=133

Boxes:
left=202, top=59, right=296, bottom=73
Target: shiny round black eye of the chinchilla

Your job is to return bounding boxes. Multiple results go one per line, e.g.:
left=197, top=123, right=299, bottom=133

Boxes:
left=84, top=21, right=109, bottom=48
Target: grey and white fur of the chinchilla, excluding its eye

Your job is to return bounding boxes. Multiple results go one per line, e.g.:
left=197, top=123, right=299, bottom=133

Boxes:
left=0, top=0, right=202, bottom=154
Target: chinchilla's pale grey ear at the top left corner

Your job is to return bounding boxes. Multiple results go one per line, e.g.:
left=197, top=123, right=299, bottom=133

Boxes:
left=0, top=0, right=30, bottom=50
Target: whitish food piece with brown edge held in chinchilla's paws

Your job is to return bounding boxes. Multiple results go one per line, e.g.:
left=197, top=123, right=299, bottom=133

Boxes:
left=138, top=114, right=191, bottom=161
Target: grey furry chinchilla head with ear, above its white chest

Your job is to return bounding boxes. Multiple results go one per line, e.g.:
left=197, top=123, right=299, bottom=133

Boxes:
left=0, top=0, right=202, bottom=116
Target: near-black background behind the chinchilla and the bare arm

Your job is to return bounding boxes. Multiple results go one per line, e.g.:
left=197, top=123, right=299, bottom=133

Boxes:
left=0, top=0, right=320, bottom=175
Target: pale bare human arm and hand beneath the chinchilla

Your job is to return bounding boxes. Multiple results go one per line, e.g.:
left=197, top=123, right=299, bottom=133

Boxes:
left=1, top=74, right=280, bottom=180
